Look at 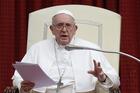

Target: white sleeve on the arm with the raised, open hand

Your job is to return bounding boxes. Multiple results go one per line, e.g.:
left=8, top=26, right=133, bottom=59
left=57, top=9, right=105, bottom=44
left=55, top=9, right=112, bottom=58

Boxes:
left=89, top=46, right=120, bottom=88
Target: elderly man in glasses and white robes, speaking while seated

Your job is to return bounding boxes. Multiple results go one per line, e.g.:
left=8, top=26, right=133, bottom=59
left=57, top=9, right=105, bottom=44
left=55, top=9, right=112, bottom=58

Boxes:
left=12, top=10, right=120, bottom=93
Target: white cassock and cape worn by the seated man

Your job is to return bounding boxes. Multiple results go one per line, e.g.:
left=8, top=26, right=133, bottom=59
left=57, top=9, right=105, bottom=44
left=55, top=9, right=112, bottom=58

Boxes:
left=12, top=38, right=120, bottom=93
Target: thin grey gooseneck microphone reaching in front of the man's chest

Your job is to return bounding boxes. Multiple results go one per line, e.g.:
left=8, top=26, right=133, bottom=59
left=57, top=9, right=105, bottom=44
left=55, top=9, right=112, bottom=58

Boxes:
left=65, top=45, right=140, bottom=62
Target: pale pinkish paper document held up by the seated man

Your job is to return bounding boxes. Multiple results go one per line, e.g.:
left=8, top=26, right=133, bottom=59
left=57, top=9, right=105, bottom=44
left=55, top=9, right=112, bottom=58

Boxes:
left=13, top=63, right=56, bottom=88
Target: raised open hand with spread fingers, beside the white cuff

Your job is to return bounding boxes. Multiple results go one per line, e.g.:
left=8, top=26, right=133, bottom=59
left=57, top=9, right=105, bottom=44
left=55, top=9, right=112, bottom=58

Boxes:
left=88, top=60, right=107, bottom=82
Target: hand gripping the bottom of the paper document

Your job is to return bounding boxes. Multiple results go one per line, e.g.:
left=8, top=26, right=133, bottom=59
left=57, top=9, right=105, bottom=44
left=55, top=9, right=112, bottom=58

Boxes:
left=21, top=81, right=35, bottom=92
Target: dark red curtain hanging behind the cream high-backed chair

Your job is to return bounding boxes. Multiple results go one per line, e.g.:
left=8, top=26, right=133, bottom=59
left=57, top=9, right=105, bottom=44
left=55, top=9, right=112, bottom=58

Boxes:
left=0, top=0, right=140, bottom=93
